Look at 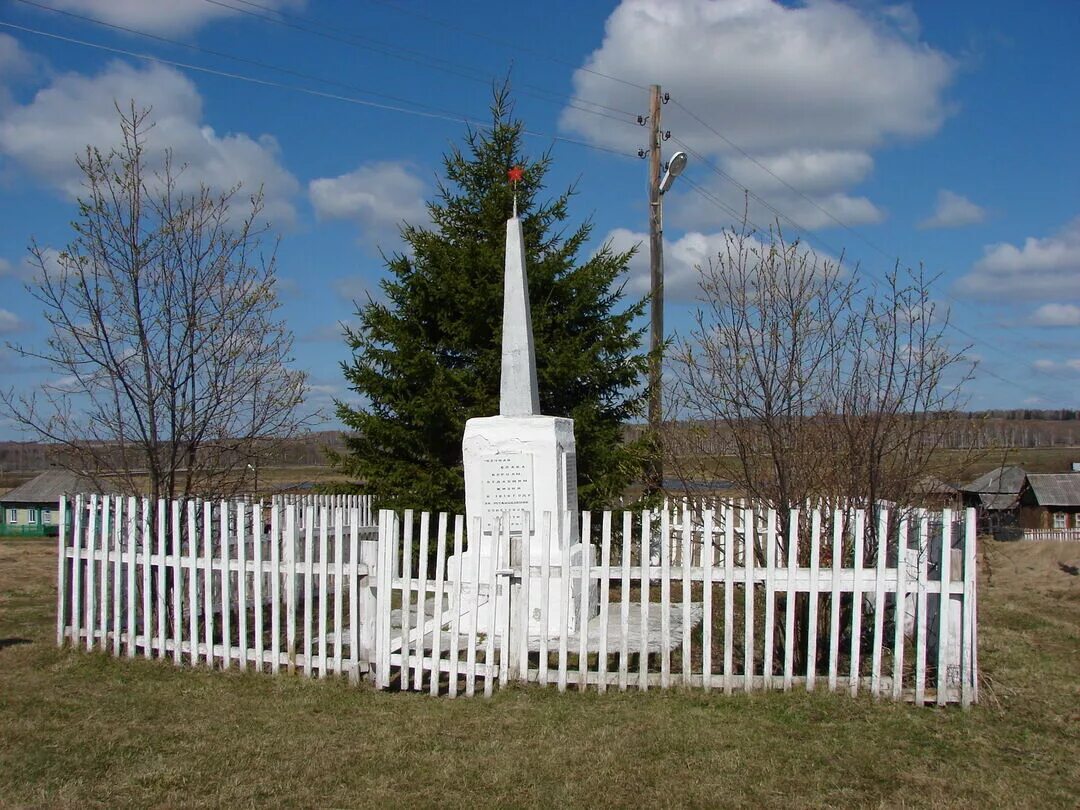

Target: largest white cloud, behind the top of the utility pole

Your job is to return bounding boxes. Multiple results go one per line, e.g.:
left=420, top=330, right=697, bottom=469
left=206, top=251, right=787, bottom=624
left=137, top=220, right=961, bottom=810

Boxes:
left=561, top=0, right=955, bottom=228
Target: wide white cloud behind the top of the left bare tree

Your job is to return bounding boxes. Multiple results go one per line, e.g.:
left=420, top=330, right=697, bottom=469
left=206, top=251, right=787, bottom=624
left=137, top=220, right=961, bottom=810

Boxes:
left=0, top=62, right=299, bottom=227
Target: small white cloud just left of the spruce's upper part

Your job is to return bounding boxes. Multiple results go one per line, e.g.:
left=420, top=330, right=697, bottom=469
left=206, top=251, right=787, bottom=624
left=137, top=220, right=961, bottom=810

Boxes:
left=308, top=161, right=428, bottom=248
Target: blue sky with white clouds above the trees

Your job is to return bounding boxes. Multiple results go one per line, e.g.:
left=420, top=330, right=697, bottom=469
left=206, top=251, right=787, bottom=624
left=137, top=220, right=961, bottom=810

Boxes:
left=0, top=0, right=1080, bottom=437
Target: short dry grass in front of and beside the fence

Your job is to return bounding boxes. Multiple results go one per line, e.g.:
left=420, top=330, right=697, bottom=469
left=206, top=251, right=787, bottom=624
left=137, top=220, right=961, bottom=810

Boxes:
left=0, top=540, right=1080, bottom=808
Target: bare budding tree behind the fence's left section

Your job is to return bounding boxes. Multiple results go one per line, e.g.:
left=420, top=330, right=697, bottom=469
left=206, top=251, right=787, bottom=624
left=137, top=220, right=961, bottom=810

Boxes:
left=0, top=105, right=307, bottom=499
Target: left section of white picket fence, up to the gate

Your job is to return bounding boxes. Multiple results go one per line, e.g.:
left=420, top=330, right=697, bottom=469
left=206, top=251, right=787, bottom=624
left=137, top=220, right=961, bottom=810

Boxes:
left=57, top=495, right=377, bottom=678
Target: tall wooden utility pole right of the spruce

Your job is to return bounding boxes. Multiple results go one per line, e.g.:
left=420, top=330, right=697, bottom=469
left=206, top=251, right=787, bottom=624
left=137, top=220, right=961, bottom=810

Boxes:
left=645, top=84, right=664, bottom=492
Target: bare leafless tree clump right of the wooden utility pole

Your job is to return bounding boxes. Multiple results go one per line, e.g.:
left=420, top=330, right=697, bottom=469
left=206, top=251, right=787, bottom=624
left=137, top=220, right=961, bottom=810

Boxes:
left=672, top=222, right=970, bottom=510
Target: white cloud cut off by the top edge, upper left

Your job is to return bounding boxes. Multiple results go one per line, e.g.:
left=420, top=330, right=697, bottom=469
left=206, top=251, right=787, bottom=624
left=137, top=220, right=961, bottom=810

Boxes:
left=33, top=0, right=305, bottom=33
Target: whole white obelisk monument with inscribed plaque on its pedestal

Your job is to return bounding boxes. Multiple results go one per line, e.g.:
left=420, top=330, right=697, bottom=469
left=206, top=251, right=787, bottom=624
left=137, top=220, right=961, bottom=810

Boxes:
left=448, top=175, right=595, bottom=635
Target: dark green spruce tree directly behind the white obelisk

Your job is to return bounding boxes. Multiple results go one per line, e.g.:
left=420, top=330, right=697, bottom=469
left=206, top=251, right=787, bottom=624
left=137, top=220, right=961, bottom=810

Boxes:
left=332, top=87, right=646, bottom=513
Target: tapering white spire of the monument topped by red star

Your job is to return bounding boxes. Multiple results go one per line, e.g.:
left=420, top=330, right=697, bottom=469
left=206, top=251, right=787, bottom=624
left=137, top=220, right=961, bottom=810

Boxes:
left=499, top=166, right=540, bottom=416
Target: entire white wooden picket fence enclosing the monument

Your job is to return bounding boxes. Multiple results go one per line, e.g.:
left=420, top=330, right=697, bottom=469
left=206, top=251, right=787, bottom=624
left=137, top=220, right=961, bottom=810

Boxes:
left=57, top=496, right=977, bottom=706
